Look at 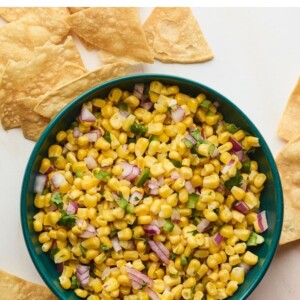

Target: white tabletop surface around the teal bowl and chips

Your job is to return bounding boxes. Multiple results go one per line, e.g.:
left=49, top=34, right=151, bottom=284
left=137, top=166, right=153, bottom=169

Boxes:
left=0, top=8, right=300, bottom=300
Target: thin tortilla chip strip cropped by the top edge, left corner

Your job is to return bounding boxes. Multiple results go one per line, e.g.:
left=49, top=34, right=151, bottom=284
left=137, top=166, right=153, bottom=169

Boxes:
left=0, top=7, right=70, bottom=22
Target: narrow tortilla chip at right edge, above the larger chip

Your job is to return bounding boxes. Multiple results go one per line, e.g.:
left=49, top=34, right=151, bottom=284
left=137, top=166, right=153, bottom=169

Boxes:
left=277, top=78, right=300, bottom=141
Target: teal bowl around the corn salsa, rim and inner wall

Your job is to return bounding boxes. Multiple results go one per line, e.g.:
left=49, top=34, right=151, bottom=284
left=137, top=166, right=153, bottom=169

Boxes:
left=21, top=74, right=283, bottom=300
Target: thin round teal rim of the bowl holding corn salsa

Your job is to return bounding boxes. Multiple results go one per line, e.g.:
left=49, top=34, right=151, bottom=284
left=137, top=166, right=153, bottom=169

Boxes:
left=20, top=73, right=284, bottom=300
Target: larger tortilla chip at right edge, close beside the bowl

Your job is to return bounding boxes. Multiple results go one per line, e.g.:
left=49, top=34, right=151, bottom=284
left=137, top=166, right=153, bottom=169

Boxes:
left=276, top=137, right=300, bottom=245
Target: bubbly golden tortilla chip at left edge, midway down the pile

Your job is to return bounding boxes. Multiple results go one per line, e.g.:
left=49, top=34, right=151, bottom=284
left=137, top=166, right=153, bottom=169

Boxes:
left=0, top=37, right=86, bottom=129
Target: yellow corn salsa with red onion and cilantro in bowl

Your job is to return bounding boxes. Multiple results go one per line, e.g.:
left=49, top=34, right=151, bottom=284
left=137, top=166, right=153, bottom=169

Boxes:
left=33, top=81, right=268, bottom=300
